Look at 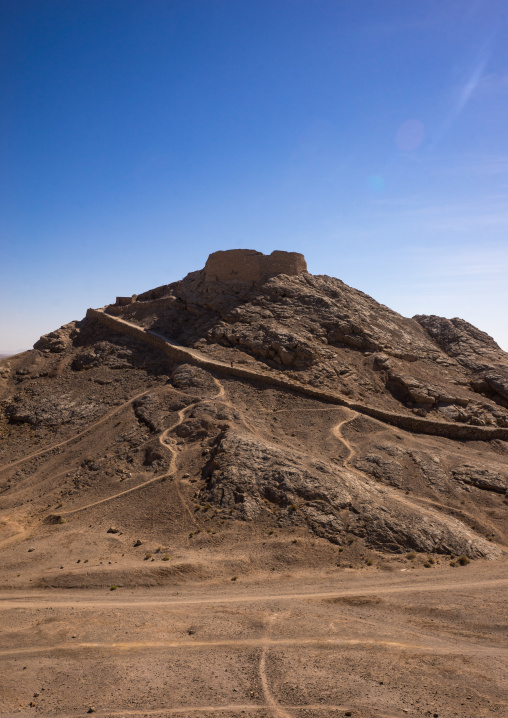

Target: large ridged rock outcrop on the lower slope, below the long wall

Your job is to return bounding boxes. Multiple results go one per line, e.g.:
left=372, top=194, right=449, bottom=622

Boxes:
left=200, top=431, right=499, bottom=558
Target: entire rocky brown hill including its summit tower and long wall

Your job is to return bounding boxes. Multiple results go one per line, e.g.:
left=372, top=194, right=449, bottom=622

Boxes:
left=0, top=250, right=508, bottom=586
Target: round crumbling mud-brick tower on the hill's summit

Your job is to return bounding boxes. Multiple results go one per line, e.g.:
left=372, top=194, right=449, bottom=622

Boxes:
left=205, top=249, right=307, bottom=282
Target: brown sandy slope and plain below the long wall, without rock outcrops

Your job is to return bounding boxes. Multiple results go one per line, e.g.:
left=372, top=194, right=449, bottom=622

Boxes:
left=0, top=338, right=508, bottom=718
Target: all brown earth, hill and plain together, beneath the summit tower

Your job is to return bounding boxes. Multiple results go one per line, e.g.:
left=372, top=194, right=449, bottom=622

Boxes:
left=0, top=253, right=508, bottom=718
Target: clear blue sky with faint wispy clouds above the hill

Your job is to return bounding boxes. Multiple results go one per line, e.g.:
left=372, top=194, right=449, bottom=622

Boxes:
left=0, top=0, right=508, bottom=351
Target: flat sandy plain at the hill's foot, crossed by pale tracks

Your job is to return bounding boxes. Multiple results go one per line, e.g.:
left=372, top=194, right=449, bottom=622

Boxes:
left=0, top=559, right=508, bottom=718
